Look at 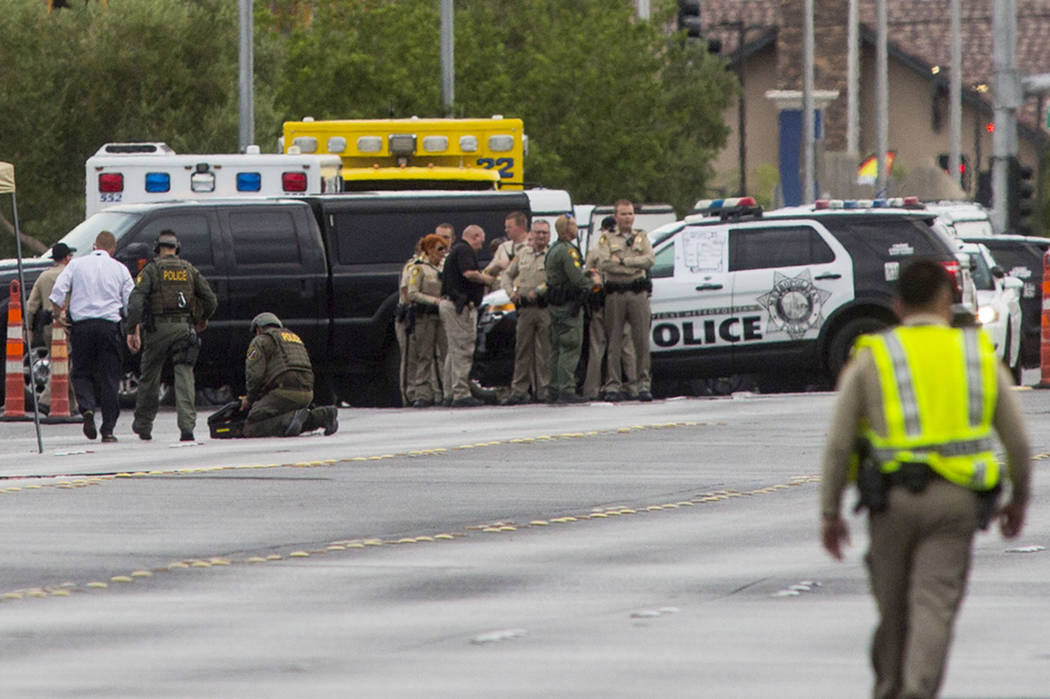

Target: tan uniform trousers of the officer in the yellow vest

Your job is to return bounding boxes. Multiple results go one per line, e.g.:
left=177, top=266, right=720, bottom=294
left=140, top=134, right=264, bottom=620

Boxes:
left=865, top=478, right=978, bottom=699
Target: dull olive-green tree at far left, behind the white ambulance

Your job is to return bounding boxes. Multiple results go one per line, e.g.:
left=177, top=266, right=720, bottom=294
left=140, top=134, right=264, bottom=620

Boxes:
left=0, top=0, right=279, bottom=255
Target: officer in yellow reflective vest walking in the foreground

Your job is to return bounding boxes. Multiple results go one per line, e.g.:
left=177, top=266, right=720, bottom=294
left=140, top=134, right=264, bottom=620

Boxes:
left=821, top=260, right=1030, bottom=699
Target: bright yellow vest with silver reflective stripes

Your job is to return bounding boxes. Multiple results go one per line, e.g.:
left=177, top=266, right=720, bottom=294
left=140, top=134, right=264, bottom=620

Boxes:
left=854, top=325, right=1000, bottom=490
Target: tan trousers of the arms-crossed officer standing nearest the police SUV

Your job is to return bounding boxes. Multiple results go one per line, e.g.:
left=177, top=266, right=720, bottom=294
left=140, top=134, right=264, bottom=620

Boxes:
left=605, top=292, right=652, bottom=396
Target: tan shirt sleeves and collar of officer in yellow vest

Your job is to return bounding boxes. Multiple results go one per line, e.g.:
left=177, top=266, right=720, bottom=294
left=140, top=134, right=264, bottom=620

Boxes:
left=820, top=315, right=1031, bottom=516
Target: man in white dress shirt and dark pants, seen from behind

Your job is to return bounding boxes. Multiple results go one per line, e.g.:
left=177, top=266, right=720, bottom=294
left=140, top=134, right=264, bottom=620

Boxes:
left=49, top=231, right=134, bottom=442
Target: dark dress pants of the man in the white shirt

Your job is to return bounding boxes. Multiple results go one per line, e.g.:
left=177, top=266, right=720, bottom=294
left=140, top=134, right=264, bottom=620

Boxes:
left=70, top=318, right=124, bottom=435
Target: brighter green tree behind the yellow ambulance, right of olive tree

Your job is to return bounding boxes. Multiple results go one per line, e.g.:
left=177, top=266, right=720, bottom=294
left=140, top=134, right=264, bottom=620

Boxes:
left=266, top=0, right=737, bottom=212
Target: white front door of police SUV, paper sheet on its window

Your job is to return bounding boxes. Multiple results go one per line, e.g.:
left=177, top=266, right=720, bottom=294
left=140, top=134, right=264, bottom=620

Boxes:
left=650, top=226, right=734, bottom=376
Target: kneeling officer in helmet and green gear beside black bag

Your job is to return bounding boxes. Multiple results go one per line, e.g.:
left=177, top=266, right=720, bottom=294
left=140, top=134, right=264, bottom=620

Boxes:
left=240, top=313, right=339, bottom=437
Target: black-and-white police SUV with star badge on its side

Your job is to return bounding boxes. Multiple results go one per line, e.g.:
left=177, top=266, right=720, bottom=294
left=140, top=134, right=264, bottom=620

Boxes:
left=650, top=197, right=960, bottom=380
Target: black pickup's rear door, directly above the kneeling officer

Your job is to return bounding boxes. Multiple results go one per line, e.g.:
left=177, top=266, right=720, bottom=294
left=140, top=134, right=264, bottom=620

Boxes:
left=218, top=204, right=328, bottom=374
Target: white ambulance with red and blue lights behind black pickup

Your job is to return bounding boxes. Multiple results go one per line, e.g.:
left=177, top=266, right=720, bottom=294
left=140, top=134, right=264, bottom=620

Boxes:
left=85, top=143, right=343, bottom=216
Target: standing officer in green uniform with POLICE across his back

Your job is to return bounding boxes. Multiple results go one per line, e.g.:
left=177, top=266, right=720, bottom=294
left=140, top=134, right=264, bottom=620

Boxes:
left=127, top=230, right=218, bottom=442
